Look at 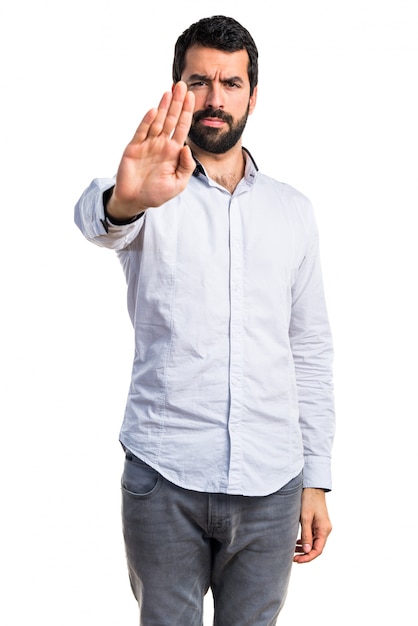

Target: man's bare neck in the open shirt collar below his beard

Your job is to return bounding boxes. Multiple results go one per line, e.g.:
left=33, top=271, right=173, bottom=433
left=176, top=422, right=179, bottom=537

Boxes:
left=190, top=142, right=245, bottom=193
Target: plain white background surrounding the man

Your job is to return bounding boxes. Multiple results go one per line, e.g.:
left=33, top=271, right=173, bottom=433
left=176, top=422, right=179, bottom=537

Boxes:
left=0, top=0, right=418, bottom=626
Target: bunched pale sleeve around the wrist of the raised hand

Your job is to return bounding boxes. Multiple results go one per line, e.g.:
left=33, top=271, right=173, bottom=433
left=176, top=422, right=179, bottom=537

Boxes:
left=74, top=178, right=144, bottom=250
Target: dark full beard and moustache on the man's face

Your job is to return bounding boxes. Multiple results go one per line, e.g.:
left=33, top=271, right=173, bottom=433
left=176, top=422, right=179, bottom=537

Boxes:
left=189, top=105, right=249, bottom=154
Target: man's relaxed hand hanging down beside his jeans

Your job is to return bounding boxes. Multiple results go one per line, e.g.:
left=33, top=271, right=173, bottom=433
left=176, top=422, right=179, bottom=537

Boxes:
left=293, top=489, right=332, bottom=563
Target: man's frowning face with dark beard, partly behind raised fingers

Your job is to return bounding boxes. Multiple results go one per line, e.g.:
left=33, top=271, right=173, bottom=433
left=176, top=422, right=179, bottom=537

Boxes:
left=181, top=46, right=257, bottom=154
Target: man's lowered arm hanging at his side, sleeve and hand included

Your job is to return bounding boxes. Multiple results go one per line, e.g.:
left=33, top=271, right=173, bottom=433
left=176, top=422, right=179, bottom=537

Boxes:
left=289, top=204, right=335, bottom=563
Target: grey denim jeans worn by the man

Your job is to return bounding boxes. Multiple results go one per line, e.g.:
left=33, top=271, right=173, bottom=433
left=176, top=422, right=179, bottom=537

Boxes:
left=122, top=451, right=302, bottom=626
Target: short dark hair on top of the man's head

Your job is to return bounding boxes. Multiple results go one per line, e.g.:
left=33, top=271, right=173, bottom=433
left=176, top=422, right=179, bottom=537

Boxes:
left=173, top=15, right=258, bottom=94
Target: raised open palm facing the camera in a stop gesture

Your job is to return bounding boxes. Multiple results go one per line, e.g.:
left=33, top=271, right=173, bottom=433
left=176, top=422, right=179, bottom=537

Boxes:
left=107, top=82, right=196, bottom=219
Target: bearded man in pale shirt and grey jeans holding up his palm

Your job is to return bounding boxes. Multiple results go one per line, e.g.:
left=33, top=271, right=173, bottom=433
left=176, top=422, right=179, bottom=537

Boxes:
left=76, top=16, right=334, bottom=626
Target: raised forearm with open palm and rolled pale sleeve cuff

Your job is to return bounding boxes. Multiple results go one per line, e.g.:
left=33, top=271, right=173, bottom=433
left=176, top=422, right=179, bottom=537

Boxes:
left=75, top=82, right=196, bottom=249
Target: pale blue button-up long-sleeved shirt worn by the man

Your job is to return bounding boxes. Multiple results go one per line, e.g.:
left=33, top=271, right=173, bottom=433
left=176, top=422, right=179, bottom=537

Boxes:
left=75, top=153, right=334, bottom=496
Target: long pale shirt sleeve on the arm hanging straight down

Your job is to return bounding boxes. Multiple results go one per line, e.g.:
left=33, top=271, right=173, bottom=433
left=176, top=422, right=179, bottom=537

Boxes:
left=289, top=205, right=335, bottom=491
